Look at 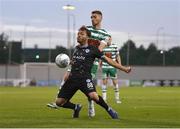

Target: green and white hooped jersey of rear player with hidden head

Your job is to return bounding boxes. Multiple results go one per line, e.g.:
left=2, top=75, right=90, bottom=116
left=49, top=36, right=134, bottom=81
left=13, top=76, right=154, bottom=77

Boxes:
left=102, top=44, right=119, bottom=68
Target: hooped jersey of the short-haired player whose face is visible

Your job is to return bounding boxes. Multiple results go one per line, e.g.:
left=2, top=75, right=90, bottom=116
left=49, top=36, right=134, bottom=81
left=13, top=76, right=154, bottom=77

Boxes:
left=86, top=26, right=110, bottom=65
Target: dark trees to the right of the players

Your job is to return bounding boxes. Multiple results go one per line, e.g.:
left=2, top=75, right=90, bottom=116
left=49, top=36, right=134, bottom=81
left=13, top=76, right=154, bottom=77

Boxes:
left=120, top=40, right=180, bottom=66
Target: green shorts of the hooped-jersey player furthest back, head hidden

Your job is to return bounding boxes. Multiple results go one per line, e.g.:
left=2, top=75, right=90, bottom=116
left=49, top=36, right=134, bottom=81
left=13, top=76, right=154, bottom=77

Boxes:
left=102, top=68, right=117, bottom=79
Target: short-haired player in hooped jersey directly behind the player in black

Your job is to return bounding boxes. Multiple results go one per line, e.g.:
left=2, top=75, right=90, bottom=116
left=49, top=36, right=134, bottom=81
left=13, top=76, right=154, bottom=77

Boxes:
left=87, top=11, right=110, bottom=117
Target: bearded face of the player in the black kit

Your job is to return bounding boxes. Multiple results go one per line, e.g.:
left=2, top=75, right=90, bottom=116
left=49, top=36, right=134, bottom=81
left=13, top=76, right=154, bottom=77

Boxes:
left=77, top=30, right=88, bottom=45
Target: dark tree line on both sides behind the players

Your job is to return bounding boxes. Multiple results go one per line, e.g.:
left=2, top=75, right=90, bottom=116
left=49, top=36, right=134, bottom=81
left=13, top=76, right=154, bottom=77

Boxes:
left=0, top=33, right=180, bottom=66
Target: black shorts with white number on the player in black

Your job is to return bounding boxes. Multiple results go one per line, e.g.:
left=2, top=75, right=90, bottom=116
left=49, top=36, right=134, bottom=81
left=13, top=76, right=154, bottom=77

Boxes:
left=57, top=78, right=96, bottom=100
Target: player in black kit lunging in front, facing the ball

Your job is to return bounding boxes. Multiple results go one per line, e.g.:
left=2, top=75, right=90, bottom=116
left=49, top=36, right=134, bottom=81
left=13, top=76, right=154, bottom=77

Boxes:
left=56, top=26, right=130, bottom=119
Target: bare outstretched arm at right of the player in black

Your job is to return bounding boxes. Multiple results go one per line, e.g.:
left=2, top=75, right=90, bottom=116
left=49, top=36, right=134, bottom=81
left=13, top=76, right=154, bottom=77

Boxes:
left=103, top=56, right=131, bottom=73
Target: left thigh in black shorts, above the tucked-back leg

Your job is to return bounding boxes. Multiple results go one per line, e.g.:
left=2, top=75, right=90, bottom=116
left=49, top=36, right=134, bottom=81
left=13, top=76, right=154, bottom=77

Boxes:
left=57, top=79, right=78, bottom=100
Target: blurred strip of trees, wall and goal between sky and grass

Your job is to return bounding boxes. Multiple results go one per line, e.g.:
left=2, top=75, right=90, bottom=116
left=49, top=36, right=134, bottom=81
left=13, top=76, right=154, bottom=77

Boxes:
left=0, top=32, right=180, bottom=86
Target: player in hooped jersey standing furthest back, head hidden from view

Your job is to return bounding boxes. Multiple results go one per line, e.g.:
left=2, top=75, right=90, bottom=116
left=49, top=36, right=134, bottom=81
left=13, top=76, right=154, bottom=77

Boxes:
left=101, top=36, right=121, bottom=103
